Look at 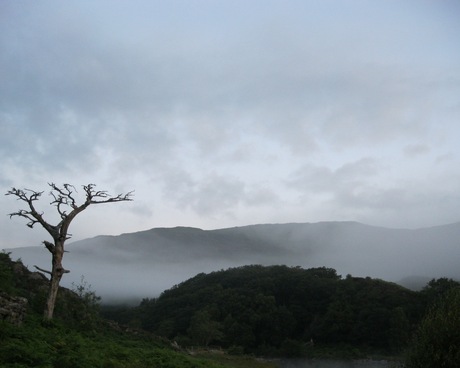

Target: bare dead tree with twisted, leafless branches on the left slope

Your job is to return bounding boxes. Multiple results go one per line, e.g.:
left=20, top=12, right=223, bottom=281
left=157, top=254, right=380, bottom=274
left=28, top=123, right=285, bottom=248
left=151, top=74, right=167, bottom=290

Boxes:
left=6, top=183, right=133, bottom=320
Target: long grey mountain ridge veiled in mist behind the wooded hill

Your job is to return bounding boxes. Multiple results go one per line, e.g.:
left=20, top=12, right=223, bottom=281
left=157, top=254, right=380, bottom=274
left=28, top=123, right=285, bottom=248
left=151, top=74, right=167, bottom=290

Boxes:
left=4, top=222, right=460, bottom=300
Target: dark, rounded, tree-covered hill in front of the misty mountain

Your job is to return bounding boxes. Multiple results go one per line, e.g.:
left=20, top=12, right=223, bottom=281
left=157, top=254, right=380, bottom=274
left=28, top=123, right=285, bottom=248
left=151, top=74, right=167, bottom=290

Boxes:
left=106, top=265, right=458, bottom=356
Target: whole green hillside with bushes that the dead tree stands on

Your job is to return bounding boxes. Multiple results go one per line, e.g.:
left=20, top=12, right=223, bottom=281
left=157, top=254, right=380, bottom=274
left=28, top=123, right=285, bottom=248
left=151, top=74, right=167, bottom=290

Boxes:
left=0, top=253, right=272, bottom=368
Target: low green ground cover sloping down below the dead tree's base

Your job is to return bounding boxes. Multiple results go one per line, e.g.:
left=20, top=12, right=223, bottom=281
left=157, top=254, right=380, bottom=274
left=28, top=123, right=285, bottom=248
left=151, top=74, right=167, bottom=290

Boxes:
left=0, top=316, right=274, bottom=368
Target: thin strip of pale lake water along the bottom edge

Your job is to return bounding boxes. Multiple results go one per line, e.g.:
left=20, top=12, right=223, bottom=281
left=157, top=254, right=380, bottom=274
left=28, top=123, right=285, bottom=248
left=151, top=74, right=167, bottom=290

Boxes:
left=279, top=359, right=398, bottom=368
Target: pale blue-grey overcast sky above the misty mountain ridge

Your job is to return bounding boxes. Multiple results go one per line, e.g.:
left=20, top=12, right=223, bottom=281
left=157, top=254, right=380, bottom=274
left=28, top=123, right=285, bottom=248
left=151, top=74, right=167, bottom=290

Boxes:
left=0, top=0, right=460, bottom=248
